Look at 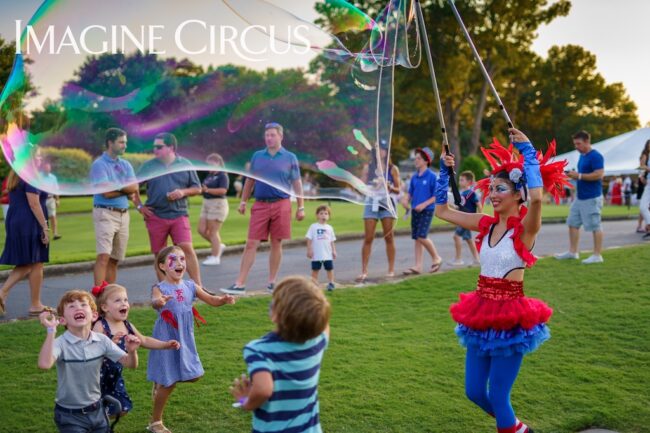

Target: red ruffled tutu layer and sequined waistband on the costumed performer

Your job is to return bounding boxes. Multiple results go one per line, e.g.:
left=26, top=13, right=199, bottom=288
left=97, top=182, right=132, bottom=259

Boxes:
left=449, top=275, right=553, bottom=331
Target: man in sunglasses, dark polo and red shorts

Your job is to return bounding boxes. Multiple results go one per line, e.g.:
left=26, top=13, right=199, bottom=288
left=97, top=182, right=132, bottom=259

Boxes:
left=133, top=132, right=202, bottom=286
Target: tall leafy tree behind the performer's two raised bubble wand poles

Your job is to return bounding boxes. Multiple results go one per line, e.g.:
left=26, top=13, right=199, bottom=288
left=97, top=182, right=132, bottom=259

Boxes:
left=308, top=0, right=570, bottom=165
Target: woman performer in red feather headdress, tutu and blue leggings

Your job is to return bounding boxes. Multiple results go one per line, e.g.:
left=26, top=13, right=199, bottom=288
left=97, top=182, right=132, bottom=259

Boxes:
left=436, top=128, right=568, bottom=433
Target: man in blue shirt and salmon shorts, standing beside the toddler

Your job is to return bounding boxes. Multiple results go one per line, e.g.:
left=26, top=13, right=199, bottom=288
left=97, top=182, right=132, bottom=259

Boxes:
left=221, top=123, right=305, bottom=295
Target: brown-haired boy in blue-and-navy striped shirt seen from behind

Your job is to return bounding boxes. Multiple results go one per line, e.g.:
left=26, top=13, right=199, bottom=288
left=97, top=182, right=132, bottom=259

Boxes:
left=230, top=277, right=330, bottom=433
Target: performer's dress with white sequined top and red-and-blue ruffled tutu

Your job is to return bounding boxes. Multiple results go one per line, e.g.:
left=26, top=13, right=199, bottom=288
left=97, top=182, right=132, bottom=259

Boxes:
left=449, top=206, right=553, bottom=356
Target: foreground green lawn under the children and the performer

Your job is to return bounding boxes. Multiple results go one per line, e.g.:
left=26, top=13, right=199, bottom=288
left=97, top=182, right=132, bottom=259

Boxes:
left=0, top=246, right=650, bottom=433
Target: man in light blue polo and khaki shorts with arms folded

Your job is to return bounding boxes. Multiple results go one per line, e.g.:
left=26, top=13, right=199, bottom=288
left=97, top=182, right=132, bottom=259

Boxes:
left=90, top=128, right=138, bottom=286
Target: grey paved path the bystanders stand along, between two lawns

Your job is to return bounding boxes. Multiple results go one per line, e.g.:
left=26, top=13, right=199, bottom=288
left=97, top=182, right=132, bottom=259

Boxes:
left=2, top=220, right=643, bottom=321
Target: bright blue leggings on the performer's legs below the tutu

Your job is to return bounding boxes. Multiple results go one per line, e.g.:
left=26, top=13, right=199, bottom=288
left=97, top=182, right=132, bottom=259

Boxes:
left=465, top=346, right=523, bottom=428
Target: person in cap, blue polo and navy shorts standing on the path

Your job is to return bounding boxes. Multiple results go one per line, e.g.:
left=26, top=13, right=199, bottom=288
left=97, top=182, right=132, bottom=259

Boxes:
left=403, top=147, right=442, bottom=275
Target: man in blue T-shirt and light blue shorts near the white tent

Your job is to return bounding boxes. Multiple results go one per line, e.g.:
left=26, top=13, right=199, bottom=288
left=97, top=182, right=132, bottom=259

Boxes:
left=555, top=131, right=605, bottom=265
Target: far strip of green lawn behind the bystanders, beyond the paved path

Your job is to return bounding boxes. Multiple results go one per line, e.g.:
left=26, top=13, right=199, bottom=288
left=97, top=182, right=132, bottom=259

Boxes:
left=0, top=197, right=638, bottom=269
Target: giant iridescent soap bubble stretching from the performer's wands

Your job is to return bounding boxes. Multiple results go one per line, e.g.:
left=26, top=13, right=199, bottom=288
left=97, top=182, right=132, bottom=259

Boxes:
left=0, top=0, right=419, bottom=213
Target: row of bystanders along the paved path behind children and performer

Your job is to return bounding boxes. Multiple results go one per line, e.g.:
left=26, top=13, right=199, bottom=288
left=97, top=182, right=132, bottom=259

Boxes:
left=0, top=123, right=650, bottom=314
